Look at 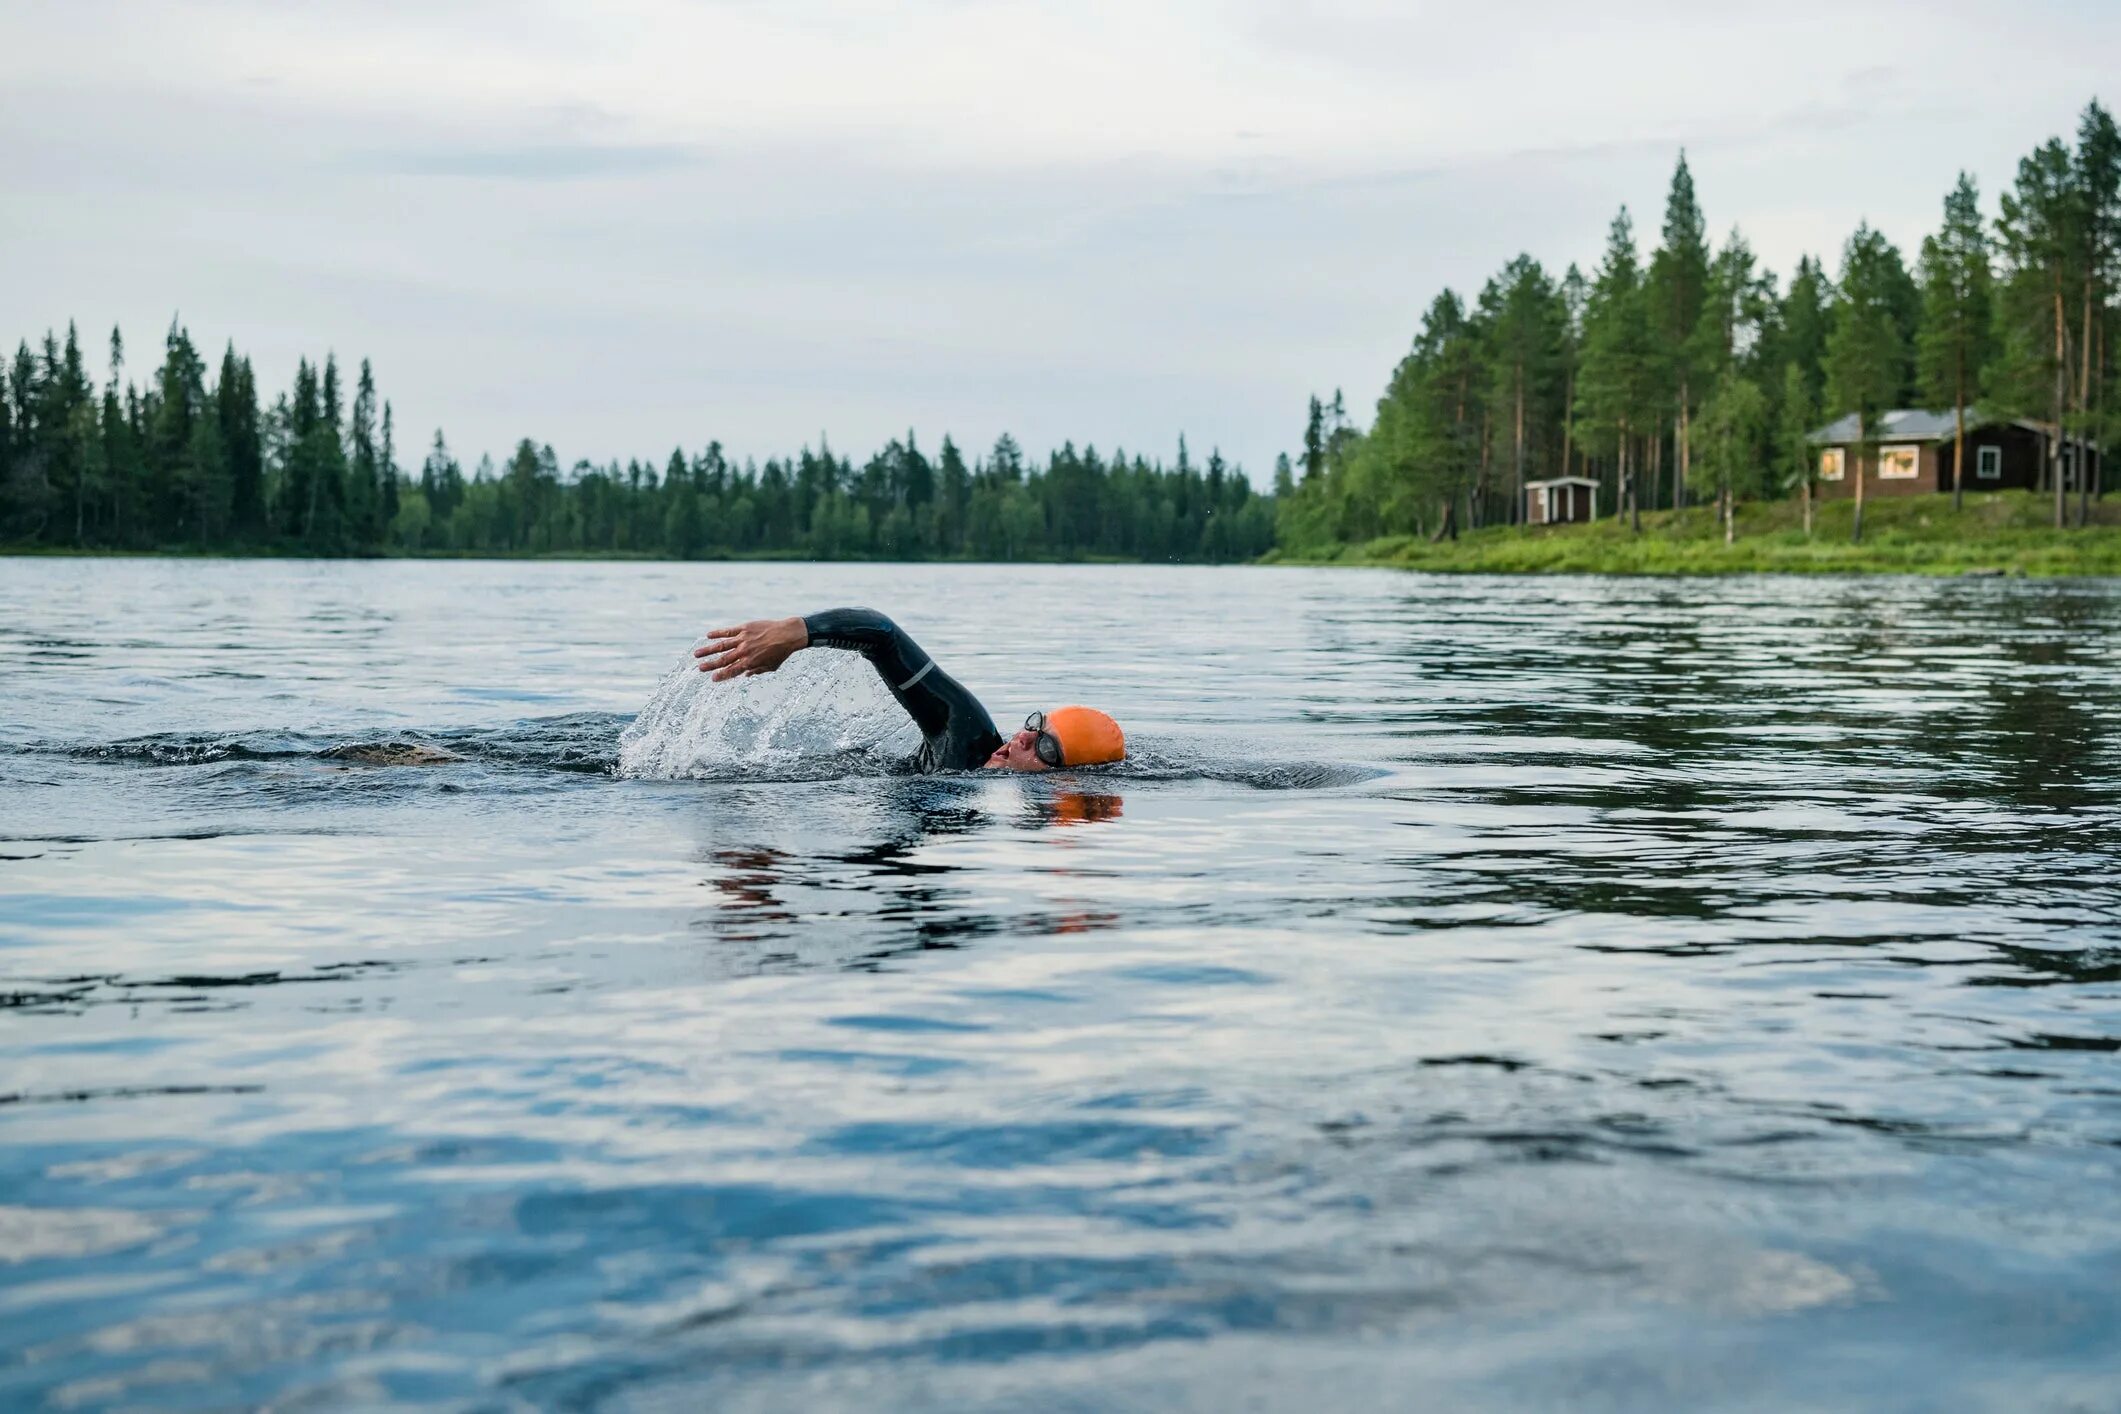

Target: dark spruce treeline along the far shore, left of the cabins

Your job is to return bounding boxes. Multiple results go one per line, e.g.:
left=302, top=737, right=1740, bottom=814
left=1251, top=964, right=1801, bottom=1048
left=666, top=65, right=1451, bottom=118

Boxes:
left=0, top=324, right=1275, bottom=562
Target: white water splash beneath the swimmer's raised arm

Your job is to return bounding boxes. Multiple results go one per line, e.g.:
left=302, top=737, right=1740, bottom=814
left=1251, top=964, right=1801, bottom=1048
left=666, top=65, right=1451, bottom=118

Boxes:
left=619, top=653, right=918, bottom=780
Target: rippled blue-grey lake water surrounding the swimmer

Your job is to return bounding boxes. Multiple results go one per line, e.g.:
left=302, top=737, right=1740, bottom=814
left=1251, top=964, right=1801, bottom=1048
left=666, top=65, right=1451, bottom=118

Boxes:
left=0, top=560, right=2121, bottom=1410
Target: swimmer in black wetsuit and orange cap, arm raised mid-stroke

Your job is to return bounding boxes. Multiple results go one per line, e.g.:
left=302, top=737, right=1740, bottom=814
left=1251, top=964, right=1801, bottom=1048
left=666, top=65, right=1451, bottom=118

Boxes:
left=691, top=608, right=1126, bottom=772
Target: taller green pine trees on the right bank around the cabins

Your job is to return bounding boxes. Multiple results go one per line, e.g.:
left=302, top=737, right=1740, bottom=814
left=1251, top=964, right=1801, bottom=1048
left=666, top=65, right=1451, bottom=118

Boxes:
left=1279, top=102, right=2121, bottom=553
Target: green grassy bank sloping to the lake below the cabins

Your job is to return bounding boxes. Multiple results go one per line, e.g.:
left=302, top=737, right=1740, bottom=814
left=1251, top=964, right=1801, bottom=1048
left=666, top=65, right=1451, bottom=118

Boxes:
left=1270, top=492, right=2121, bottom=575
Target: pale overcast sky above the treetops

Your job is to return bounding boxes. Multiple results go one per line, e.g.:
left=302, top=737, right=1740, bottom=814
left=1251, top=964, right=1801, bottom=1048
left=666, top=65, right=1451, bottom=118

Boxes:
left=0, top=0, right=2121, bottom=481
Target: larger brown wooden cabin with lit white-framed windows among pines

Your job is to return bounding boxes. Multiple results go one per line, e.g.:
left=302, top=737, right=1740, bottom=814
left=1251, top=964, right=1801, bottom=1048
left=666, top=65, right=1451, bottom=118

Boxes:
left=1807, top=407, right=2102, bottom=498
